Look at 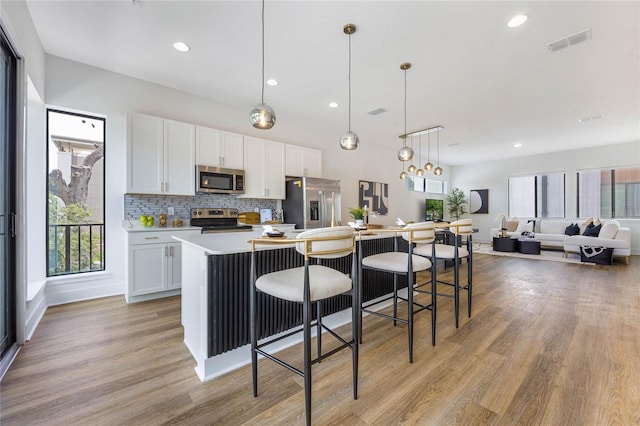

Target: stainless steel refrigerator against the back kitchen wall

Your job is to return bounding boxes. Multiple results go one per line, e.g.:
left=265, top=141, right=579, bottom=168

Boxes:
left=282, top=177, right=341, bottom=229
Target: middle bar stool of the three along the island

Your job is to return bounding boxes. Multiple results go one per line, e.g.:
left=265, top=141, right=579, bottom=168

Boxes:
left=358, top=222, right=436, bottom=363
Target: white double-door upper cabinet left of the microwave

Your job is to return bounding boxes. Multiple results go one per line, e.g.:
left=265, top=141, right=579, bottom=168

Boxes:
left=127, top=114, right=195, bottom=195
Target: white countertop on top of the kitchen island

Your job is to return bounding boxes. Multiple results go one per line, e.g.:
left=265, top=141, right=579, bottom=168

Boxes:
left=173, top=229, right=396, bottom=255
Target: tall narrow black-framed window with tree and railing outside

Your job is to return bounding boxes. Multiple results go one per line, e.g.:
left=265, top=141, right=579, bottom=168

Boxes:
left=47, top=109, right=106, bottom=276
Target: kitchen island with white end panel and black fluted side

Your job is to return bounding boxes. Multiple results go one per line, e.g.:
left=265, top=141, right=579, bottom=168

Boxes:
left=174, top=231, right=406, bottom=381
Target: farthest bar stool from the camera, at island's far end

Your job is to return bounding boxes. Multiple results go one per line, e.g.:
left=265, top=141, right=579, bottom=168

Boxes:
left=414, top=219, right=473, bottom=328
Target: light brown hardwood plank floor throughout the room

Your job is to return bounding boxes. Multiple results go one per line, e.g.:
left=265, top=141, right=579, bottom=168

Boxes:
left=0, top=254, right=640, bottom=425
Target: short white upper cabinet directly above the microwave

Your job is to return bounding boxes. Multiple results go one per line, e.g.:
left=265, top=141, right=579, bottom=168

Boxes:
left=196, top=126, right=244, bottom=170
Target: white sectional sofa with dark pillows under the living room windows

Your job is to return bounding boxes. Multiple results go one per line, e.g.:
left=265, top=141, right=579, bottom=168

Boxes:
left=491, top=219, right=631, bottom=264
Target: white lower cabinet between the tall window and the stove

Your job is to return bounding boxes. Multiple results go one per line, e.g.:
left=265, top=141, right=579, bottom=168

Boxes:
left=125, top=230, right=198, bottom=303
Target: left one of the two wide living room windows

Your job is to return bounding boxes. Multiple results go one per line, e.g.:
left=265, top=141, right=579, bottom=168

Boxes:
left=509, top=173, right=565, bottom=217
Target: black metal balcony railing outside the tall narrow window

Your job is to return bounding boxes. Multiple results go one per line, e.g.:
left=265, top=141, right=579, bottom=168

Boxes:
left=47, top=223, right=104, bottom=277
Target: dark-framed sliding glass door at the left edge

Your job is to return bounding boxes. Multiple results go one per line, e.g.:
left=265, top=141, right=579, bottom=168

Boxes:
left=0, top=32, right=16, bottom=360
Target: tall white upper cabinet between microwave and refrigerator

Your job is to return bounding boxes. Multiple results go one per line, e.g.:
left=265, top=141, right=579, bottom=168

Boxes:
left=242, top=136, right=285, bottom=200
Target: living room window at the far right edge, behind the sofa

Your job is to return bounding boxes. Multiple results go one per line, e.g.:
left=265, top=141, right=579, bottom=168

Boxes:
left=578, top=167, right=640, bottom=219
